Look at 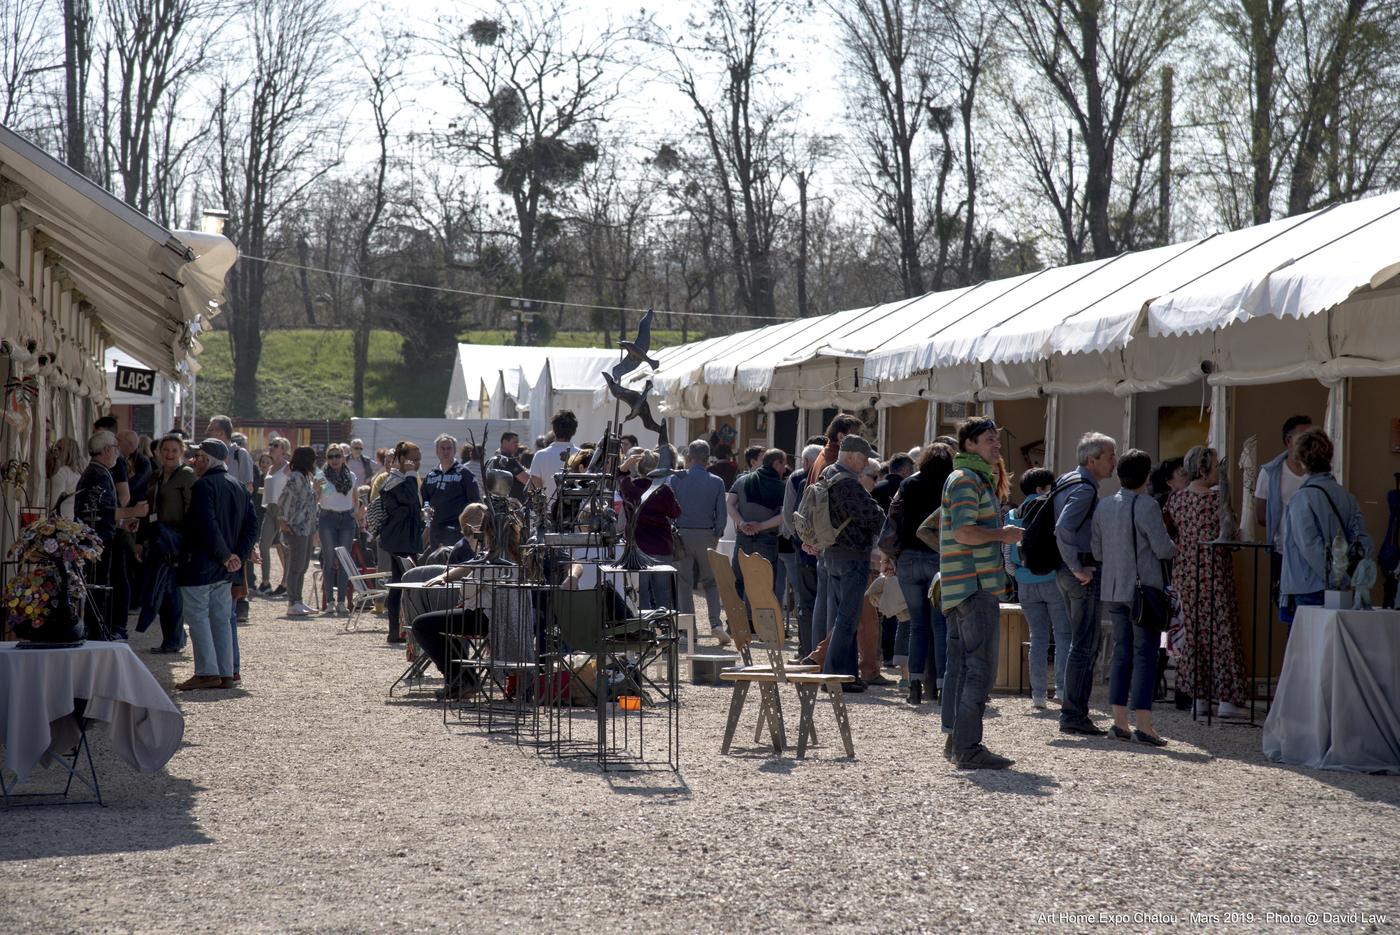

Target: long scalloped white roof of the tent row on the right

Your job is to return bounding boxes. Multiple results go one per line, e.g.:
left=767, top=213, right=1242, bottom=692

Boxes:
left=633, top=187, right=1400, bottom=416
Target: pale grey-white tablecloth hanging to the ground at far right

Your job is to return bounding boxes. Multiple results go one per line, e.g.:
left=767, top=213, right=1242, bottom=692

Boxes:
left=1264, top=607, right=1400, bottom=773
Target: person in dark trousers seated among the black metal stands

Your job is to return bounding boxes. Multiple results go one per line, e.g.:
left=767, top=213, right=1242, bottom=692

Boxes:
left=413, top=507, right=535, bottom=700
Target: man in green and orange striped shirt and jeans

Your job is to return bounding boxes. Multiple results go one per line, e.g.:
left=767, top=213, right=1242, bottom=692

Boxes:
left=939, top=419, right=1022, bottom=770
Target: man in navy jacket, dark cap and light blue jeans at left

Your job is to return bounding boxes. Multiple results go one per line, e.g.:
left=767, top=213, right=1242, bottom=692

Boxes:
left=175, top=438, right=258, bottom=691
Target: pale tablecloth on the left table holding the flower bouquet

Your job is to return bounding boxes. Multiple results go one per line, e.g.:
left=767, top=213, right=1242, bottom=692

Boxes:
left=0, top=642, right=185, bottom=781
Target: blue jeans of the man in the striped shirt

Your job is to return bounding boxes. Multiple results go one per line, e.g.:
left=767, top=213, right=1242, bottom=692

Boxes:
left=942, top=591, right=1001, bottom=757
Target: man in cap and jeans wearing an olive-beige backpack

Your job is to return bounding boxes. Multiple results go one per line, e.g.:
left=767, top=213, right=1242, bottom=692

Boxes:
left=822, top=434, right=885, bottom=691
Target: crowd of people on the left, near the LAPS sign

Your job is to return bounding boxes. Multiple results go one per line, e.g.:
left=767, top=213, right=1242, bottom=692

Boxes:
left=46, top=416, right=546, bottom=690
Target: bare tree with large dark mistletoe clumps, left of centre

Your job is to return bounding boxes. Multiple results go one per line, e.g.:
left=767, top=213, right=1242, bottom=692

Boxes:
left=440, top=1, right=616, bottom=307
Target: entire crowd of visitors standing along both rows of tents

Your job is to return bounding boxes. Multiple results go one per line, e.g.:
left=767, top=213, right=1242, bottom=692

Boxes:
left=48, top=412, right=1371, bottom=768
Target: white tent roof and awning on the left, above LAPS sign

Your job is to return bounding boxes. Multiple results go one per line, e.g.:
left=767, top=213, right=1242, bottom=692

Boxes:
left=0, top=126, right=238, bottom=377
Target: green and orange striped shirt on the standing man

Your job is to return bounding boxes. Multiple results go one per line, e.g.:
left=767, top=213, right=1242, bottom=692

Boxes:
left=938, top=468, right=1007, bottom=613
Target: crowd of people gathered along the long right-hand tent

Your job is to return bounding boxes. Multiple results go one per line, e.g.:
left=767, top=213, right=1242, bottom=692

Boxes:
left=646, top=414, right=1371, bottom=768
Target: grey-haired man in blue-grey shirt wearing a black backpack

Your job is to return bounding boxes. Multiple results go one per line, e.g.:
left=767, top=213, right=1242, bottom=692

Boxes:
left=1052, top=433, right=1119, bottom=736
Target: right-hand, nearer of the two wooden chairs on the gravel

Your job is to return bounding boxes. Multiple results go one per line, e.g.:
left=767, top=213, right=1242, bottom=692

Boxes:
left=721, top=551, right=855, bottom=760
